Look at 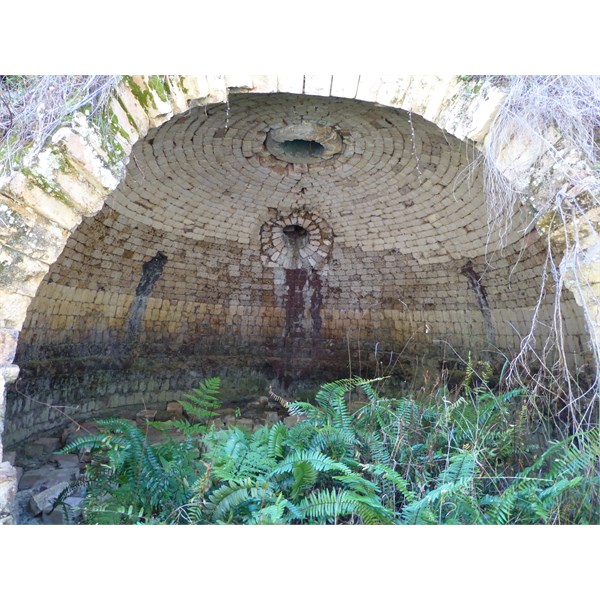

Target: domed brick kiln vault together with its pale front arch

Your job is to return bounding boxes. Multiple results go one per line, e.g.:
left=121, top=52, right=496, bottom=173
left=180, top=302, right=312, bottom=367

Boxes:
left=0, top=77, right=586, bottom=516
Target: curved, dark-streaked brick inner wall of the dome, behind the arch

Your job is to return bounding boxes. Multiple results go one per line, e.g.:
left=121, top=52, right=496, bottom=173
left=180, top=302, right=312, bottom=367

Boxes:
left=5, top=94, right=586, bottom=445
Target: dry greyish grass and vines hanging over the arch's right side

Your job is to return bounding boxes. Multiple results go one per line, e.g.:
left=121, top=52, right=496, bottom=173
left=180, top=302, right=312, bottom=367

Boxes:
left=482, top=76, right=600, bottom=429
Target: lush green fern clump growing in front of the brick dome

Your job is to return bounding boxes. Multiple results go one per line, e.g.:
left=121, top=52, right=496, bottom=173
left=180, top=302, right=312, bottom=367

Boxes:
left=59, top=364, right=600, bottom=524
